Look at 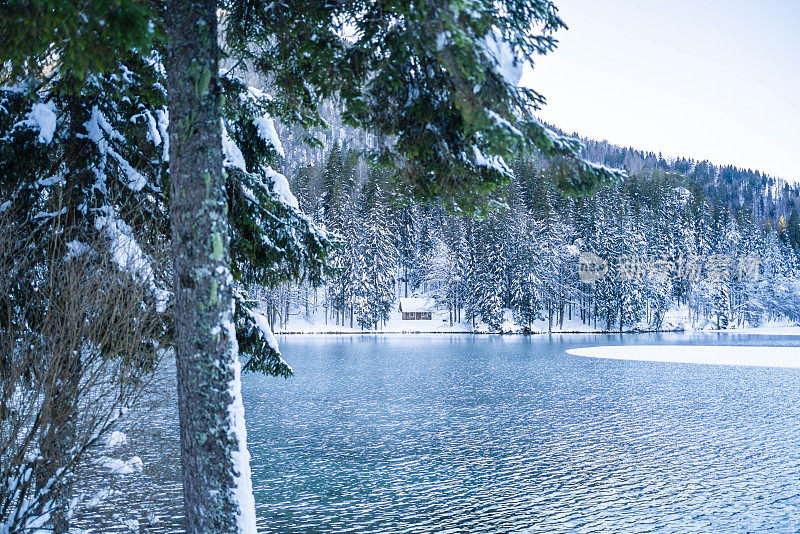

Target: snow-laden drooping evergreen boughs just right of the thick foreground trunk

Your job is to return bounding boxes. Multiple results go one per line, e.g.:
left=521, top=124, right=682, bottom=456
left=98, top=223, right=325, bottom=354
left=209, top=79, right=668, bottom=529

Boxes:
left=216, top=72, right=336, bottom=376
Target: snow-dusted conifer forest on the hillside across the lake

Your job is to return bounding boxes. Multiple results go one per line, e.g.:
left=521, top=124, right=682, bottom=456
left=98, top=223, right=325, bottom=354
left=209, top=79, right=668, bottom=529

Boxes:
left=253, top=110, right=800, bottom=331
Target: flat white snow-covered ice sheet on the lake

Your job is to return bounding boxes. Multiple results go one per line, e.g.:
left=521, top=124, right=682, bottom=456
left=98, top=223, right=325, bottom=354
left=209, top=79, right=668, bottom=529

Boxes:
left=567, top=345, right=800, bottom=369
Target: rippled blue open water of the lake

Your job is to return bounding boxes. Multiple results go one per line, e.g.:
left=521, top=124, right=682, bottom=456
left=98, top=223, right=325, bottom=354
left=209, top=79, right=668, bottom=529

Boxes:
left=244, top=334, right=800, bottom=533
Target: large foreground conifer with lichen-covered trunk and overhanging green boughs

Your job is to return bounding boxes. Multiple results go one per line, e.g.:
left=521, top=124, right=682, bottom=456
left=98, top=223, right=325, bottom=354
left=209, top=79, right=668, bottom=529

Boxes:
left=9, top=0, right=619, bottom=532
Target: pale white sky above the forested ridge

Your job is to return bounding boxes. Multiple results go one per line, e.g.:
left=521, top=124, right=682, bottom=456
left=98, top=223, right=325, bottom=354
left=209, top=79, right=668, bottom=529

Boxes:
left=522, top=0, right=800, bottom=182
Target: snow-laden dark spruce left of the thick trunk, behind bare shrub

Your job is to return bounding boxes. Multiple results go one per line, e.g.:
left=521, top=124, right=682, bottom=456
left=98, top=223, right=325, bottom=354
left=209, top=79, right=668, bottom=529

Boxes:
left=0, top=55, right=169, bottom=532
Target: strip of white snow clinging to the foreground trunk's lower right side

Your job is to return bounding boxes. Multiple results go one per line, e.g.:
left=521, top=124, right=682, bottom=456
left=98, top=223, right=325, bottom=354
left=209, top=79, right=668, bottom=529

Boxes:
left=222, top=304, right=258, bottom=534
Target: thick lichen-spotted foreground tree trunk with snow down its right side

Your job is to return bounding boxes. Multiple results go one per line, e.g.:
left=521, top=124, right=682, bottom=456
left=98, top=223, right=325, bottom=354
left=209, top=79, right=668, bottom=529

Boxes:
left=165, top=0, right=256, bottom=533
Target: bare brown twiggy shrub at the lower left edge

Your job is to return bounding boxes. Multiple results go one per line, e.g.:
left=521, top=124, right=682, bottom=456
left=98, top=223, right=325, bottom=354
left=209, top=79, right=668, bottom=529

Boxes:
left=0, top=215, right=169, bottom=534
